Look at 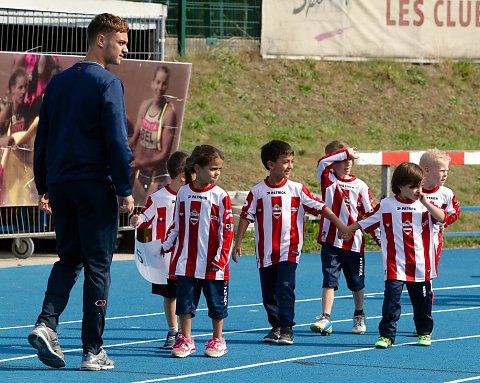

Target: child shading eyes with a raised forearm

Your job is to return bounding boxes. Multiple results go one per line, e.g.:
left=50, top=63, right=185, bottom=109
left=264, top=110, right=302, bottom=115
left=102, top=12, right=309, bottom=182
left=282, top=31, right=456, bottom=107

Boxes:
left=310, top=141, right=378, bottom=335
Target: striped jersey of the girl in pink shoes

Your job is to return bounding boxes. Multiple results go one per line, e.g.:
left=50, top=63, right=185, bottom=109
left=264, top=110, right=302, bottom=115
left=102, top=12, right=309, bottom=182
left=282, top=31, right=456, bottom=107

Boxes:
left=163, top=183, right=233, bottom=280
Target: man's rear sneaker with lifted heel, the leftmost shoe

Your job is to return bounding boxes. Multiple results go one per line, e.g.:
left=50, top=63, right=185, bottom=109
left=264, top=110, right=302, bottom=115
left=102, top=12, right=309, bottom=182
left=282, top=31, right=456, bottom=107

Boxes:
left=28, top=323, right=65, bottom=368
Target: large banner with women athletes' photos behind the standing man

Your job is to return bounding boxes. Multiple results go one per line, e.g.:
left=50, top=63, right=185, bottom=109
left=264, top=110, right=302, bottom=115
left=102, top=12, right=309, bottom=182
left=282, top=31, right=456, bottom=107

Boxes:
left=0, top=52, right=192, bottom=206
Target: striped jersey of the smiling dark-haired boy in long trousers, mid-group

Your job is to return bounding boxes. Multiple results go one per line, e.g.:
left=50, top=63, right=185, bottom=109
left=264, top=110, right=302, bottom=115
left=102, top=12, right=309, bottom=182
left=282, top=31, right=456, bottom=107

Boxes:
left=240, top=178, right=325, bottom=268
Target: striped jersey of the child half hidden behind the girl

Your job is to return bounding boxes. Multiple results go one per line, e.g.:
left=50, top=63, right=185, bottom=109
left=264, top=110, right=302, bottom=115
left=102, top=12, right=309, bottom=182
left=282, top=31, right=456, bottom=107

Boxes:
left=138, top=185, right=177, bottom=275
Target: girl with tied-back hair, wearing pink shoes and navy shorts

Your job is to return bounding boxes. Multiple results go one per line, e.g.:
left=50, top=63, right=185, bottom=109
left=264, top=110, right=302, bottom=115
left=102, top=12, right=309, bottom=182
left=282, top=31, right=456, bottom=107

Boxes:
left=162, top=145, right=233, bottom=358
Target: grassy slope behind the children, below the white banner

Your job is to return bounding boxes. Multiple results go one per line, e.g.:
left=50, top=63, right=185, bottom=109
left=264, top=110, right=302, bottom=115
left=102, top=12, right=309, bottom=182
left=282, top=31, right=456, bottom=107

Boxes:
left=180, top=49, right=480, bottom=254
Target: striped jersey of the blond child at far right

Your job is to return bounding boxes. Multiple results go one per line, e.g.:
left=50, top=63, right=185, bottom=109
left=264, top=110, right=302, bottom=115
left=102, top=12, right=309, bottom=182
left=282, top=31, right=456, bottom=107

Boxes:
left=423, top=186, right=460, bottom=256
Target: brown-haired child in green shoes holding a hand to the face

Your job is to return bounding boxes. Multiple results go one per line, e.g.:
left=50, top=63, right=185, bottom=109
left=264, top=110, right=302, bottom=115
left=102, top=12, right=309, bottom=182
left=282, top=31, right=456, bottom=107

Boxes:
left=348, top=162, right=446, bottom=348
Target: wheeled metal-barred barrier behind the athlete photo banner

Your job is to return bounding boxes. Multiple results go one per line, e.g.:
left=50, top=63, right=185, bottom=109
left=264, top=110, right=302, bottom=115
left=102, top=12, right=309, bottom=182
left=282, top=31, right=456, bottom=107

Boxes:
left=0, top=8, right=165, bottom=258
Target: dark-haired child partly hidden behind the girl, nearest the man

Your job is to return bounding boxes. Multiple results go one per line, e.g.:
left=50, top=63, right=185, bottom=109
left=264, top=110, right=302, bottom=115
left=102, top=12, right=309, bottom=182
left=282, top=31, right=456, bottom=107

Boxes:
left=130, top=151, right=188, bottom=349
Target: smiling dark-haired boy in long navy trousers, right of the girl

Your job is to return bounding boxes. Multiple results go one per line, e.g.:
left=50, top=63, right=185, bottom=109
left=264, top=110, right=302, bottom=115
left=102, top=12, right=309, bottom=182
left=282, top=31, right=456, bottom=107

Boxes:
left=232, top=140, right=346, bottom=344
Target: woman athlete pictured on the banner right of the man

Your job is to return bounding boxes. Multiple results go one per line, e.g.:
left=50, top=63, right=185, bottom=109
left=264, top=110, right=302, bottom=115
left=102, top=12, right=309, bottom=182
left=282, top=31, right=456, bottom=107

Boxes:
left=129, top=65, right=177, bottom=204
